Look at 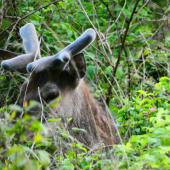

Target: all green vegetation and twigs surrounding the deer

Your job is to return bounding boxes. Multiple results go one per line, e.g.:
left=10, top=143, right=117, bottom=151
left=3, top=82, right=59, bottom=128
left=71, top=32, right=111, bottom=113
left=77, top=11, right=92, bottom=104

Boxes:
left=0, top=0, right=170, bottom=170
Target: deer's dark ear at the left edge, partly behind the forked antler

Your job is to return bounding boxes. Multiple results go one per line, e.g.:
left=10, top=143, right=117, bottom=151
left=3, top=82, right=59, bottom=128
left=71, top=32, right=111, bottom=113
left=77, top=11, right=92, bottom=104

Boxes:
left=0, top=50, right=28, bottom=74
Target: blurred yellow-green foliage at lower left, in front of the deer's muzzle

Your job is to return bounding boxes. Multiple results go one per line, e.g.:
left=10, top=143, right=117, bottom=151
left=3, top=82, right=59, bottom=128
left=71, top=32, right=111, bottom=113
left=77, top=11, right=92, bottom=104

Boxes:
left=0, top=102, right=117, bottom=170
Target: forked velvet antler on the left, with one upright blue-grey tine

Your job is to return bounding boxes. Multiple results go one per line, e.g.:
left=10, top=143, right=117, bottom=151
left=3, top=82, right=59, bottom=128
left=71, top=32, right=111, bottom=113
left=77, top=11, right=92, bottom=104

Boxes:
left=1, top=23, right=41, bottom=70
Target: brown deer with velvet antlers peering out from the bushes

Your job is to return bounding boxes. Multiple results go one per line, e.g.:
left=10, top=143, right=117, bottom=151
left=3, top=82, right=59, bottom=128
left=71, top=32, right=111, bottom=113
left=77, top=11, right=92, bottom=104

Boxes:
left=0, top=23, right=119, bottom=147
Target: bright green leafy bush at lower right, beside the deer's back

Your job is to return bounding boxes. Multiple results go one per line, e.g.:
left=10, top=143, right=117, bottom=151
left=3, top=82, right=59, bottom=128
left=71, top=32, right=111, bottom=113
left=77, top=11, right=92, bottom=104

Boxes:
left=116, top=77, right=170, bottom=169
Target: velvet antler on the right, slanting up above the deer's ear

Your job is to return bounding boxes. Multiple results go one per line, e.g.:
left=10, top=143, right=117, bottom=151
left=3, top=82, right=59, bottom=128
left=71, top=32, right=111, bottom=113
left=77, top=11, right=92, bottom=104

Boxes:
left=27, top=29, right=96, bottom=73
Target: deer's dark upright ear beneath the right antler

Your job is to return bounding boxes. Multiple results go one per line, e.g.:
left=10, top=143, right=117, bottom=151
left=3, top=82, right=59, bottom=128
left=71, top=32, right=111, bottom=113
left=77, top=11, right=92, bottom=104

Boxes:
left=72, top=53, right=86, bottom=78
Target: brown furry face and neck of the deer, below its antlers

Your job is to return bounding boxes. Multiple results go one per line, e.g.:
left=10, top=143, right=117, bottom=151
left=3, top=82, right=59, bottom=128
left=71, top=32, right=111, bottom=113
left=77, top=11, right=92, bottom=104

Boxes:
left=0, top=52, right=119, bottom=147
